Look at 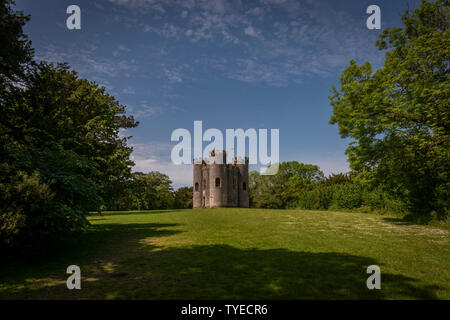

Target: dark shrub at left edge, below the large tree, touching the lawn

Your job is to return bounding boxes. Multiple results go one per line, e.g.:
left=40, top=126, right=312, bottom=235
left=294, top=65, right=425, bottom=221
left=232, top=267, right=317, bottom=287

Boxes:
left=0, top=169, right=87, bottom=255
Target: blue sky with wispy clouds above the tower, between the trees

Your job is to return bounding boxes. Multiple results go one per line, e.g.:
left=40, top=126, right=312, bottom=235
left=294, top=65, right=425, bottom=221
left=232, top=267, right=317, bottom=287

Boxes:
left=16, top=0, right=419, bottom=187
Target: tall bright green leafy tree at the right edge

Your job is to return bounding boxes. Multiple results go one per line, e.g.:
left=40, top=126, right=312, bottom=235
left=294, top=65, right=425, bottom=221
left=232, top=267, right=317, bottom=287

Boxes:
left=330, top=0, right=450, bottom=215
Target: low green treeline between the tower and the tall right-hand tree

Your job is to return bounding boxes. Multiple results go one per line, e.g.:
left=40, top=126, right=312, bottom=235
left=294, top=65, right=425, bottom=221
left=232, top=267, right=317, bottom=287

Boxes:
left=249, top=161, right=408, bottom=214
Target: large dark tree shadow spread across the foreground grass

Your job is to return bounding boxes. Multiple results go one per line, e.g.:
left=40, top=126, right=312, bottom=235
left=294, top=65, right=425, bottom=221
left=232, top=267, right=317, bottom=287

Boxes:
left=0, top=223, right=439, bottom=299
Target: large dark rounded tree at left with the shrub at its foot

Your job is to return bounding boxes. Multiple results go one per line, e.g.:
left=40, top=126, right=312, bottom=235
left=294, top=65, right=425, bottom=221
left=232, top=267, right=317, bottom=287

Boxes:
left=0, top=63, right=137, bottom=255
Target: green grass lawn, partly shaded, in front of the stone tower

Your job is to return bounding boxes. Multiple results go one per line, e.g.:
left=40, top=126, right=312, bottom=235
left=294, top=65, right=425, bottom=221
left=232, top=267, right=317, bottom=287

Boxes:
left=0, top=209, right=450, bottom=299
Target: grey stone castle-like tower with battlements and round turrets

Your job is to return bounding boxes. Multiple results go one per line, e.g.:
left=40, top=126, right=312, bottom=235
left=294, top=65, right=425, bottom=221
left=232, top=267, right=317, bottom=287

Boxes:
left=193, top=150, right=249, bottom=208
